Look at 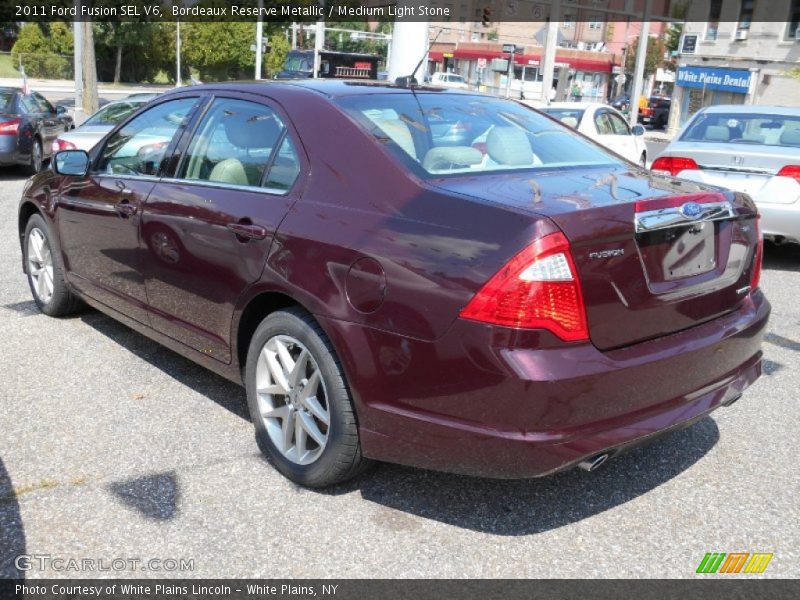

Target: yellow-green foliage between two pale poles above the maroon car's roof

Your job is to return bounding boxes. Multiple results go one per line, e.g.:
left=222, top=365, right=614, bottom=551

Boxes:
left=181, top=21, right=256, bottom=81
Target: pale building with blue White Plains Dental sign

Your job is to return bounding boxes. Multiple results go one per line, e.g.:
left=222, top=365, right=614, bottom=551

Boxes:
left=668, top=0, right=800, bottom=132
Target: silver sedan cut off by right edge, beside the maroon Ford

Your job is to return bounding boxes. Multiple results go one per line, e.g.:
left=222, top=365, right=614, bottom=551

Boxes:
left=651, top=104, right=800, bottom=243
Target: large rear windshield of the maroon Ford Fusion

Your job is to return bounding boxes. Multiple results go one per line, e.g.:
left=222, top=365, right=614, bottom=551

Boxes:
left=338, top=92, right=621, bottom=177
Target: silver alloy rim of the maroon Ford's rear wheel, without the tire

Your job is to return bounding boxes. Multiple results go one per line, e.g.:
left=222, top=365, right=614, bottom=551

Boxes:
left=256, top=335, right=331, bottom=465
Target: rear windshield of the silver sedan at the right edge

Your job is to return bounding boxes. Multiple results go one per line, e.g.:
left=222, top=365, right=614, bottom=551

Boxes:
left=681, top=113, right=800, bottom=148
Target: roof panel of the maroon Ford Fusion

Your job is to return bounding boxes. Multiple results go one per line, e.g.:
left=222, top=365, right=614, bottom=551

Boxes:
left=164, top=79, right=478, bottom=98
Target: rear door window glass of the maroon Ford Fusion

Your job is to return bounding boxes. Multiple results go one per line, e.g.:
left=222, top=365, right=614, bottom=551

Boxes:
left=177, top=98, right=299, bottom=189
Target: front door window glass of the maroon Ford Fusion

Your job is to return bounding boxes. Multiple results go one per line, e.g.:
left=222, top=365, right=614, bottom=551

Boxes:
left=95, top=98, right=197, bottom=175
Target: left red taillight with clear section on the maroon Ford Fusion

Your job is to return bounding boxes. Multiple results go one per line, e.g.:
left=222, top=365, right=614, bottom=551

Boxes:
left=461, top=233, right=589, bottom=341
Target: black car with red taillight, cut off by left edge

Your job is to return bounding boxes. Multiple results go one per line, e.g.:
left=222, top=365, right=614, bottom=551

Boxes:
left=0, top=87, right=74, bottom=175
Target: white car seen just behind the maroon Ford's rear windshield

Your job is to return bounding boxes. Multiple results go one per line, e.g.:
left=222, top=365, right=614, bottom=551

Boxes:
left=540, top=102, right=647, bottom=167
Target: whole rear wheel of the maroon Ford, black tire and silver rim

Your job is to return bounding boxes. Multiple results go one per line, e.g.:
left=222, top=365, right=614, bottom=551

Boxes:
left=245, top=308, right=369, bottom=488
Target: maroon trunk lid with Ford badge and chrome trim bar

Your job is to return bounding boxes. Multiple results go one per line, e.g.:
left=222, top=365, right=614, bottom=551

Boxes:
left=428, top=169, right=757, bottom=350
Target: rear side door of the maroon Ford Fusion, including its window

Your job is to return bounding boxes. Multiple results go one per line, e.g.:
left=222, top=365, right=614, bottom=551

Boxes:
left=142, top=93, right=305, bottom=363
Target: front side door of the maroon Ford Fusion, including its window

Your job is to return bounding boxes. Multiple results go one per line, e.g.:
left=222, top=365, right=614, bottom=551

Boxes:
left=56, top=96, right=198, bottom=323
